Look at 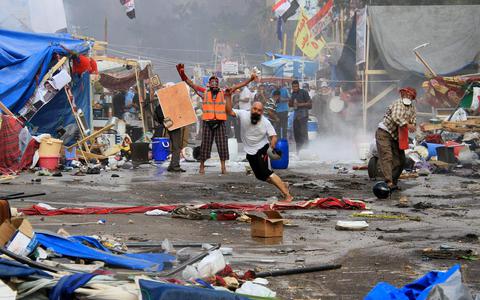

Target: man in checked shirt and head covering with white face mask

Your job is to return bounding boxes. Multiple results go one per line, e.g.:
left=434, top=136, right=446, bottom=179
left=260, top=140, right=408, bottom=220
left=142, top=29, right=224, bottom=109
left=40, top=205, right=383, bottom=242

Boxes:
left=375, top=87, right=417, bottom=190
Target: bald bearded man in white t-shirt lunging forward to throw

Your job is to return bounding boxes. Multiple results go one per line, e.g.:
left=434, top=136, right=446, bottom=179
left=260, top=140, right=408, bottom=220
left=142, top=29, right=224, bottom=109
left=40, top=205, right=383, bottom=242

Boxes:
left=226, top=88, right=293, bottom=202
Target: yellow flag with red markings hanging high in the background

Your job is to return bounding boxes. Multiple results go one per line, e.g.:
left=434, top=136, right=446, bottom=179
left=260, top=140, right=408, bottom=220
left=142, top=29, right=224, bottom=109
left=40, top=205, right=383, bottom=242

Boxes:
left=294, top=10, right=325, bottom=59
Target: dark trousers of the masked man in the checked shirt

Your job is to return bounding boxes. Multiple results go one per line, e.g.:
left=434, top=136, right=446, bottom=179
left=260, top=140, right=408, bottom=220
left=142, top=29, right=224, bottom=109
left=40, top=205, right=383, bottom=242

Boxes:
left=375, top=128, right=405, bottom=184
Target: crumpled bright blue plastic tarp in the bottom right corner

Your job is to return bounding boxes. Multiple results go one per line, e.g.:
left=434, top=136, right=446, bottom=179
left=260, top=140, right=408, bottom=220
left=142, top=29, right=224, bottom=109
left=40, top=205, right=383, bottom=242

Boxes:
left=365, top=265, right=460, bottom=300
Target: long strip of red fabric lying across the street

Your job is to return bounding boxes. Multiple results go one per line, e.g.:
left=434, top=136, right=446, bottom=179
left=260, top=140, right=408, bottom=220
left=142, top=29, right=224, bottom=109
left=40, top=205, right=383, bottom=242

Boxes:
left=19, top=197, right=365, bottom=216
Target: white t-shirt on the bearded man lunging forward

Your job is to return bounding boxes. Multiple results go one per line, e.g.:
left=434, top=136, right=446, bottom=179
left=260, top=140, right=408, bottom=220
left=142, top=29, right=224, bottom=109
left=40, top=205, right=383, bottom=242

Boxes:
left=233, top=109, right=277, bottom=155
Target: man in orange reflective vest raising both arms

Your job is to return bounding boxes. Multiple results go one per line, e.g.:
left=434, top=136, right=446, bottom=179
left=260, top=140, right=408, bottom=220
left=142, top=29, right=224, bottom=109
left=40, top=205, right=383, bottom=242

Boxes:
left=177, top=64, right=256, bottom=174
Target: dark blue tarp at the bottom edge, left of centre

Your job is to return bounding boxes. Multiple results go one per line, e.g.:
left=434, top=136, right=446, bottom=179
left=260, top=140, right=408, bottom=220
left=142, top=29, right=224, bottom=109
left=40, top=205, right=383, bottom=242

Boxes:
left=138, top=279, right=248, bottom=300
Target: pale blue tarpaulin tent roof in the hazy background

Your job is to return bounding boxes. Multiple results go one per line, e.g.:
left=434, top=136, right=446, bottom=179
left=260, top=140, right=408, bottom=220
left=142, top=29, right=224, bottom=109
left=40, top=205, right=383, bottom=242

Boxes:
left=262, top=52, right=318, bottom=79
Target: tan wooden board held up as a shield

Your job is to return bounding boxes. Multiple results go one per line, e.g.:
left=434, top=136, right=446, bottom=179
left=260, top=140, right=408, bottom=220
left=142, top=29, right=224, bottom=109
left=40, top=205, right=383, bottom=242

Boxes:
left=156, top=82, right=197, bottom=130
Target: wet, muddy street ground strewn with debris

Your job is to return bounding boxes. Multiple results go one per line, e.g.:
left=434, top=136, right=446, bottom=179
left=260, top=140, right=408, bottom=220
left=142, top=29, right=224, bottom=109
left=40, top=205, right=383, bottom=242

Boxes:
left=0, top=161, right=480, bottom=299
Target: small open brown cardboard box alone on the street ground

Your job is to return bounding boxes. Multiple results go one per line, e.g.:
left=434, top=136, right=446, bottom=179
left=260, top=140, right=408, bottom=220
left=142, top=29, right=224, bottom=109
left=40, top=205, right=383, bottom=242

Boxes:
left=248, top=210, right=283, bottom=238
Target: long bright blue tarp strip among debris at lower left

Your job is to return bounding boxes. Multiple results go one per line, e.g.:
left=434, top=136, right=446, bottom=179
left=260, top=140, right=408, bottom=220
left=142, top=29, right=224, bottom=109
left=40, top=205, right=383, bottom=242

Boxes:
left=36, top=233, right=175, bottom=272
